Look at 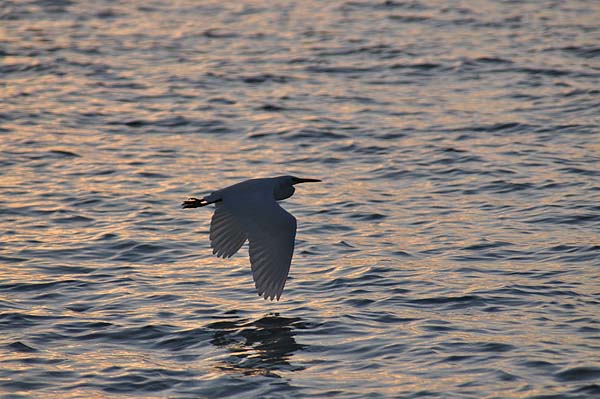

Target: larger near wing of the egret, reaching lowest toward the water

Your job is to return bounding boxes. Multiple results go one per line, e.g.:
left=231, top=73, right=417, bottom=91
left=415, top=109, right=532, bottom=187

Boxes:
left=223, top=191, right=296, bottom=300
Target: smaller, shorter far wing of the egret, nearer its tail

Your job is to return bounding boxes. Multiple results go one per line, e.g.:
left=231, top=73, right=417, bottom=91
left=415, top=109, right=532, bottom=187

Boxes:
left=210, top=202, right=247, bottom=258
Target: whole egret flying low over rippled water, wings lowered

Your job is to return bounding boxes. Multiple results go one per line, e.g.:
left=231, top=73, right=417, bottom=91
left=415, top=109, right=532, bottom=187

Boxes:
left=182, top=176, right=321, bottom=300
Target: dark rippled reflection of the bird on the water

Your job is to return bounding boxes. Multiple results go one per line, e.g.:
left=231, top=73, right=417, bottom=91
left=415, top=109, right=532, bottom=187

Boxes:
left=207, top=313, right=306, bottom=377
